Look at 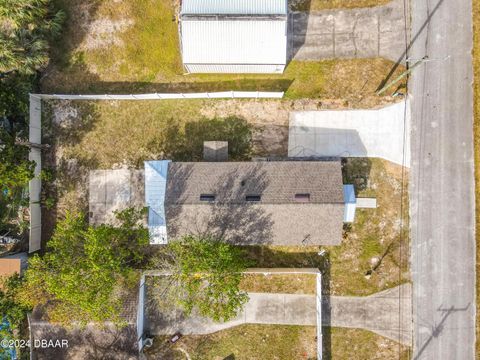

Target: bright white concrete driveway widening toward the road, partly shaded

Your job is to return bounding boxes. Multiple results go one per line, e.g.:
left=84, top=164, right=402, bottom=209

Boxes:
left=288, top=101, right=410, bottom=167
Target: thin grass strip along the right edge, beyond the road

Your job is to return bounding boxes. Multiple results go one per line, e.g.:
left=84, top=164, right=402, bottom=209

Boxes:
left=472, top=0, right=480, bottom=355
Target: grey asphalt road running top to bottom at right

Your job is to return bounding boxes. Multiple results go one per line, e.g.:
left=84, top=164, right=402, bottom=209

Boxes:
left=409, top=0, right=475, bottom=360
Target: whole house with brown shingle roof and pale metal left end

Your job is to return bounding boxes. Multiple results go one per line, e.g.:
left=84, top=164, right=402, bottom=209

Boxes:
left=145, top=160, right=352, bottom=245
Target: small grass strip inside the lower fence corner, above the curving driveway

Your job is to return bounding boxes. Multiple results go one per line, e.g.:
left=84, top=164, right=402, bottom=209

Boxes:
left=240, top=274, right=316, bottom=295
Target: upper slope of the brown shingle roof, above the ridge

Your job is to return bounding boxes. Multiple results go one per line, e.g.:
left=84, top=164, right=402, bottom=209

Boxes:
left=165, top=161, right=344, bottom=205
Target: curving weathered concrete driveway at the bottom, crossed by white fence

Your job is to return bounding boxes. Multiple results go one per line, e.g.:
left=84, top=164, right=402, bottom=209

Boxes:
left=147, top=284, right=411, bottom=345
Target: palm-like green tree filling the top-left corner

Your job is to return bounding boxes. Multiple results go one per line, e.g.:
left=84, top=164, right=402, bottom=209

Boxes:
left=0, top=0, right=65, bottom=74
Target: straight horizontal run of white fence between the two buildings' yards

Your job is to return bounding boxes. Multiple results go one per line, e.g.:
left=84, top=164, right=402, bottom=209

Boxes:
left=31, top=91, right=283, bottom=100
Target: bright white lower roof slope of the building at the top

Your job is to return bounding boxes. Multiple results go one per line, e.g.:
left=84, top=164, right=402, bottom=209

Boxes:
left=181, top=20, right=287, bottom=64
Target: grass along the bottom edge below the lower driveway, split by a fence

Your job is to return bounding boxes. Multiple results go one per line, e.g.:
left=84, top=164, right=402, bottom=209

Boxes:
left=146, top=325, right=409, bottom=360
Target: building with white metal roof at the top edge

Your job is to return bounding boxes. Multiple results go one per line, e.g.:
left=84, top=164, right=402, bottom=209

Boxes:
left=180, top=0, right=288, bottom=73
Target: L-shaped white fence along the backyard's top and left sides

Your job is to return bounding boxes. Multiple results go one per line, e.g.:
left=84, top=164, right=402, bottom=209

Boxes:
left=29, top=91, right=283, bottom=252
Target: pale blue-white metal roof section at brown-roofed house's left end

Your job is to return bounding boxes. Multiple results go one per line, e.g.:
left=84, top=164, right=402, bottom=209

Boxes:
left=144, top=160, right=170, bottom=244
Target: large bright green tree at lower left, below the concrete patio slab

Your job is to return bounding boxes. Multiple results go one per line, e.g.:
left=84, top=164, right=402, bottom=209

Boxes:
left=20, top=209, right=148, bottom=324
